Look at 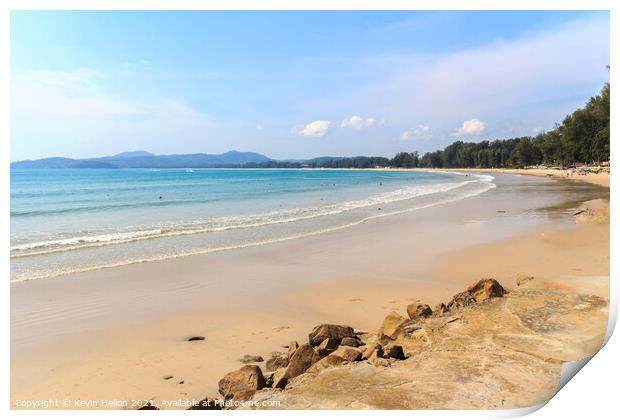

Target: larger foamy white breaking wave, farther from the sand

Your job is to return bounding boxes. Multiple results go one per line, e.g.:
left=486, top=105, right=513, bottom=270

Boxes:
left=10, top=175, right=493, bottom=258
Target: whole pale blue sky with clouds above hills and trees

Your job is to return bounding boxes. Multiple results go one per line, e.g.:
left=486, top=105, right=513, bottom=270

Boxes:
left=11, top=11, right=610, bottom=161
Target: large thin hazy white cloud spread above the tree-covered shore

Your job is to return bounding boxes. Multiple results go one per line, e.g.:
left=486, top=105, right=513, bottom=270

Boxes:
left=314, top=15, right=610, bottom=148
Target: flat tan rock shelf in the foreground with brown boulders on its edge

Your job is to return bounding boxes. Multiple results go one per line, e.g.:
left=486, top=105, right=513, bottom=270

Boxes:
left=248, top=277, right=609, bottom=409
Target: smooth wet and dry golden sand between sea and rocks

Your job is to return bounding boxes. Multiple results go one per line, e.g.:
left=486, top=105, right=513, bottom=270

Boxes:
left=11, top=170, right=609, bottom=408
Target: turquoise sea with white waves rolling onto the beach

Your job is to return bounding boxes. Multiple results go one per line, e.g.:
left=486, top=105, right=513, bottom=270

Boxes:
left=11, top=169, right=494, bottom=281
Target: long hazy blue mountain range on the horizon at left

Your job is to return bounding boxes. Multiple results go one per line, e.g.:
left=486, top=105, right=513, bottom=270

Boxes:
left=11, top=150, right=275, bottom=169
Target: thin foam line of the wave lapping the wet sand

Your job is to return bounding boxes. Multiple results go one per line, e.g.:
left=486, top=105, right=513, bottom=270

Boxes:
left=11, top=175, right=496, bottom=283
